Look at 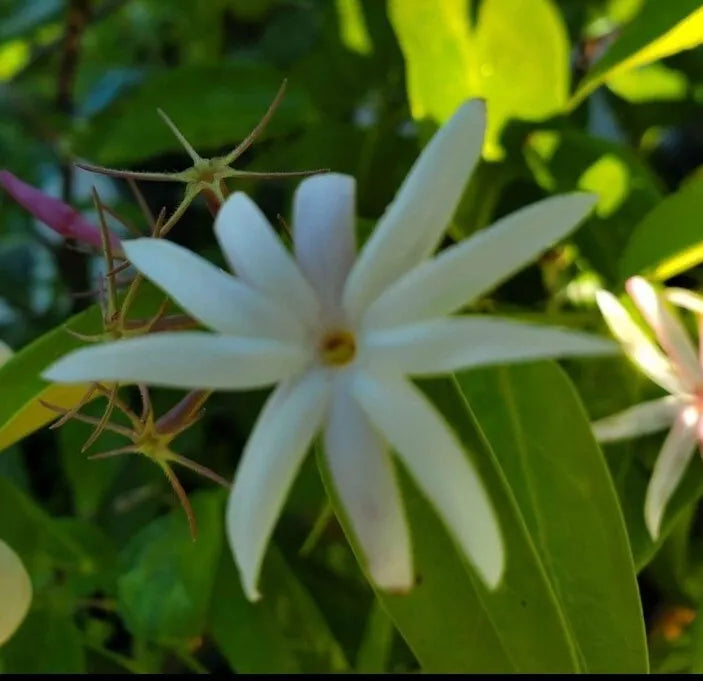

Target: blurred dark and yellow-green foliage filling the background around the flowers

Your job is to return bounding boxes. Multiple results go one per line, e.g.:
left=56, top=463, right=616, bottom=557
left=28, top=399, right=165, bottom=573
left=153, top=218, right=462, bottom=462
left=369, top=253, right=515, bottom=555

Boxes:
left=0, top=0, right=703, bottom=673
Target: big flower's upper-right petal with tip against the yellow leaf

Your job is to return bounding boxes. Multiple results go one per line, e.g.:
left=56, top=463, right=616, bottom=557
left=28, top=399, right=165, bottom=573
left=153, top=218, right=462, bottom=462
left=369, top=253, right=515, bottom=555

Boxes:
left=344, top=100, right=486, bottom=320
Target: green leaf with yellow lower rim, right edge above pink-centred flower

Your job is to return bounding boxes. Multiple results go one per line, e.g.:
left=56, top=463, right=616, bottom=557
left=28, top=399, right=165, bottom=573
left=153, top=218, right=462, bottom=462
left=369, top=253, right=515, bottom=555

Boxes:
left=622, top=173, right=703, bottom=281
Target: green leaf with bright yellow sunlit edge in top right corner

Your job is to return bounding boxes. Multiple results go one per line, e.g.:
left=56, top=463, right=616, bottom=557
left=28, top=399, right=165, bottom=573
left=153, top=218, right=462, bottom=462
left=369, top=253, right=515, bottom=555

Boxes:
left=570, top=0, right=703, bottom=107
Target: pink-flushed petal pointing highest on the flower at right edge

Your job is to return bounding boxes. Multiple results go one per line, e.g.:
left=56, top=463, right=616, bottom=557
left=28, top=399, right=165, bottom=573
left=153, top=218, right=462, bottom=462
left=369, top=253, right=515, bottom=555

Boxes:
left=626, top=277, right=703, bottom=390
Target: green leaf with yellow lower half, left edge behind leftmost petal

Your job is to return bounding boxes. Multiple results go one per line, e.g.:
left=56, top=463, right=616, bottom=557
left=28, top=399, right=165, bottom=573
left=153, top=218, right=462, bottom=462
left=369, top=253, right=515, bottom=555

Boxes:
left=0, top=284, right=163, bottom=452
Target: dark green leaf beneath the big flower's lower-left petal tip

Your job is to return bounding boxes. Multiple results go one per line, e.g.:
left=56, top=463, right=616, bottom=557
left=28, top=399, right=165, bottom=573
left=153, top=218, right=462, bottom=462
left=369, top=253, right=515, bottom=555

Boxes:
left=210, top=544, right=349, bottom=674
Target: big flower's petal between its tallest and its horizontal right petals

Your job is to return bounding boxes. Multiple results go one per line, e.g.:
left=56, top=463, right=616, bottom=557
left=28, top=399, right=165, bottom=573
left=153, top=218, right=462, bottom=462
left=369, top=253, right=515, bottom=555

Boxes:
left=364, top=193, right=597, bottom=328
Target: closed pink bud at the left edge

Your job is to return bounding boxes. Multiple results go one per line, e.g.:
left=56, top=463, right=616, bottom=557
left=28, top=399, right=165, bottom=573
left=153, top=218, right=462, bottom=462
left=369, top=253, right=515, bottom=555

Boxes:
left=0, top=170, right=122, bottom=252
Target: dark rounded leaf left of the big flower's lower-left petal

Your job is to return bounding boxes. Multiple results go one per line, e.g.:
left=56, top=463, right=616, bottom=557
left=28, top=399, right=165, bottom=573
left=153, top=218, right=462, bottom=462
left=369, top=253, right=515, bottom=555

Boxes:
left=117, top=490, right=224, bottom=643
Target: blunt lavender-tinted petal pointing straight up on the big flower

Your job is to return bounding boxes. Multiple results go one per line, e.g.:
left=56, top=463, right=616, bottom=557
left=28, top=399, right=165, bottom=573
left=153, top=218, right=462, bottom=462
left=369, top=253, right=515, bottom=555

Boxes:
left=293, top=173, right=356, bottom=314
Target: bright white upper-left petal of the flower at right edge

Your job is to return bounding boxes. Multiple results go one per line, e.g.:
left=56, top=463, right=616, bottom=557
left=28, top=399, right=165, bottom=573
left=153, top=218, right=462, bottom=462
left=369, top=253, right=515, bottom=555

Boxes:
left=596, top=290, right=685, bottom=393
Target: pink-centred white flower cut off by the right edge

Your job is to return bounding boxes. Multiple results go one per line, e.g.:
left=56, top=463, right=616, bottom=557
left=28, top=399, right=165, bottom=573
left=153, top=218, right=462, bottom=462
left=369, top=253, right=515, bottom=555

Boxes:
left=593, top=277, right=703, bottom=539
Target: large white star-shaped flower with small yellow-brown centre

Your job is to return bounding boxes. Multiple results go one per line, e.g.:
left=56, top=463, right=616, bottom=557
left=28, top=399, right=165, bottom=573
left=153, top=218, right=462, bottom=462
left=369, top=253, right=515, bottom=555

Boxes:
left=45, top=101, right=614, bottom=598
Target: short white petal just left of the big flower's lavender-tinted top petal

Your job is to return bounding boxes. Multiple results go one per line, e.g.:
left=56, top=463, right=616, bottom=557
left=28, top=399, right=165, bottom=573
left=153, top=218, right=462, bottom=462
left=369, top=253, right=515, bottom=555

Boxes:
left=215, top=192, right=320, bottom=323
